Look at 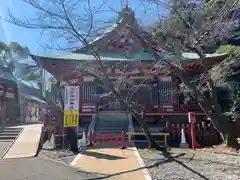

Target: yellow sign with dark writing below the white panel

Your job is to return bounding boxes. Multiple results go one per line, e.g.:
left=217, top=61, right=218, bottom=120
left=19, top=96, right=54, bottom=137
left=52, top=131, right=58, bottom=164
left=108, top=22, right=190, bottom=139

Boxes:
left=63, top=110, right=79, bottom=127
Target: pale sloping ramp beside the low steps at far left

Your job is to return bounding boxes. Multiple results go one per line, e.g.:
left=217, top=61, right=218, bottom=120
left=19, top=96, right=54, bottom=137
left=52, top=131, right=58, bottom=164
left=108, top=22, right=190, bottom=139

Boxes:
left=3, top=124, right=42, bottom=159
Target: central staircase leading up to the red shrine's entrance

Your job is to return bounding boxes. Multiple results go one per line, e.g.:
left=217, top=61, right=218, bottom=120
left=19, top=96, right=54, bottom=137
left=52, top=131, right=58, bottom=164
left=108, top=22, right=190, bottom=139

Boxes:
left=94, top=113, right=129, bottom=135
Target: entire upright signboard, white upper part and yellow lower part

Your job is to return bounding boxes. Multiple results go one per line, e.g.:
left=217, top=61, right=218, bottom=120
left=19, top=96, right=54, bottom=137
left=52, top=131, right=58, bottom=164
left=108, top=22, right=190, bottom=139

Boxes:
left=63, top=86, right=79, bottom=127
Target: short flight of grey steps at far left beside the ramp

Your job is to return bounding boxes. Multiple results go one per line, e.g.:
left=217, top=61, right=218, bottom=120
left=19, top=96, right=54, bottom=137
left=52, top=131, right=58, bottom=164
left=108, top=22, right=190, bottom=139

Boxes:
left=0, top=127, right=22, bottom=142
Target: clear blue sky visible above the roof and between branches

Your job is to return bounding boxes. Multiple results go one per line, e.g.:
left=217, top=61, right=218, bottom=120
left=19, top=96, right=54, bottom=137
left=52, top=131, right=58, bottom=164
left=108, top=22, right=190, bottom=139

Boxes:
left=0, top=0, right=167, bottom=54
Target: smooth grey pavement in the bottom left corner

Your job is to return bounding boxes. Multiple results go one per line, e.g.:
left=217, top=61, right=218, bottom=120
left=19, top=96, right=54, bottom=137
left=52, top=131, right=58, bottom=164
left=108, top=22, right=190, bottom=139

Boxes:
left=0, top=157, right=103, bottom=180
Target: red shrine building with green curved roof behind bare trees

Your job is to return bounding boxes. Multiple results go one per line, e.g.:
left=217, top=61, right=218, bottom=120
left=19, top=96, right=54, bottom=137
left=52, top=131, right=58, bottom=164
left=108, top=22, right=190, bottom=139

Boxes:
left=32, top=7, right=226, bottom=124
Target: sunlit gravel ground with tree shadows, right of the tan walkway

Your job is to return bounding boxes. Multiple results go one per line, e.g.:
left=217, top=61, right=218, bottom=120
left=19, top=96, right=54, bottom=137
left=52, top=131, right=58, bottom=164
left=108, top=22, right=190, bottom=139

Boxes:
left=139, top=149, right=240, bottom=180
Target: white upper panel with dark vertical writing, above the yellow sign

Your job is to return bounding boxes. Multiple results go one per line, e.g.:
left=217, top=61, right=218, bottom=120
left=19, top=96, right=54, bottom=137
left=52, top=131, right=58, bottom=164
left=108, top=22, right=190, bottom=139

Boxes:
left=64, top=86, right=79, bottom=110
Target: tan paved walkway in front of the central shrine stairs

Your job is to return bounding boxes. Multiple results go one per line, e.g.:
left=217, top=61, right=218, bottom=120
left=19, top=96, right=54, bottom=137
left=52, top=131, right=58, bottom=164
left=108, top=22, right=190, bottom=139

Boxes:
left=71, top=145, right=147, bottom=180
